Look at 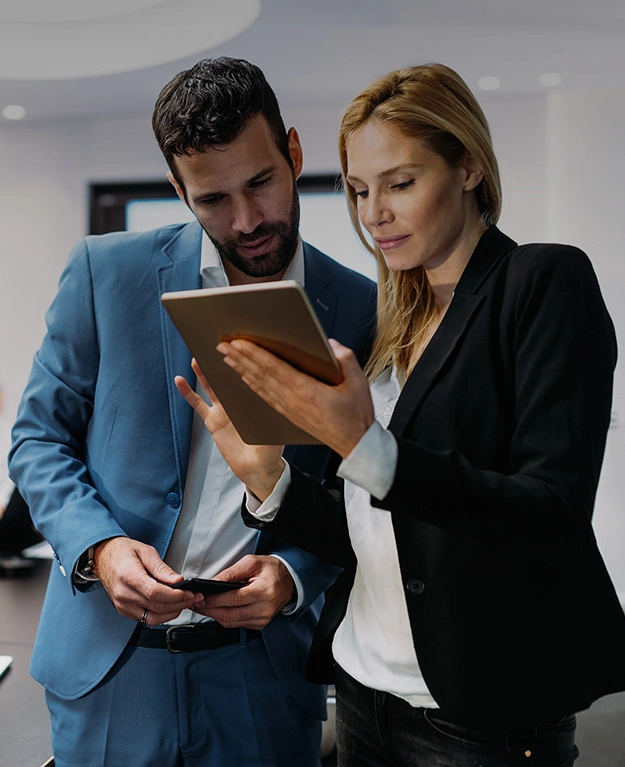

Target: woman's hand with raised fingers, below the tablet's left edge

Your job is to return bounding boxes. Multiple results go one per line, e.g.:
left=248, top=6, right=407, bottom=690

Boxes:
left=174, top=359, right=284, bottom=501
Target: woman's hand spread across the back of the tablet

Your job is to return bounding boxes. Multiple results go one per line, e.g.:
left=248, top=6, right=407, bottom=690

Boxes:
left=217, top=339, right=375, bottom=458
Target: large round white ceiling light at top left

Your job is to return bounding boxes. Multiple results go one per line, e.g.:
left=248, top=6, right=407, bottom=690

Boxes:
left=0, top=0, right=261, bottom=80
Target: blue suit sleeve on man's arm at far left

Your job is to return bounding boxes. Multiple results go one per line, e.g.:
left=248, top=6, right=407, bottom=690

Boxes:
left=10, top=242, right=124, bottom=585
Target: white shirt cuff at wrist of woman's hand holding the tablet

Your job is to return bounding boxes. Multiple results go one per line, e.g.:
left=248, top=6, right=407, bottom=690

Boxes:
left=336, top=421, right=398, bottom=501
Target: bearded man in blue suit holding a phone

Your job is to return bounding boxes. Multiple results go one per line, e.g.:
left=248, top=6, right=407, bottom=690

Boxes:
left=11, top=59, right=375, bottom=767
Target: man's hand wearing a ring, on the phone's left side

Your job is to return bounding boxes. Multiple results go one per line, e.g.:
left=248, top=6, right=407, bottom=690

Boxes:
left=94, top=537, right=202, bottom=626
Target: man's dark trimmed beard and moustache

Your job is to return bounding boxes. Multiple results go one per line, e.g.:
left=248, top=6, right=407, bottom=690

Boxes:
left=206, top=184, right=299, bottom=278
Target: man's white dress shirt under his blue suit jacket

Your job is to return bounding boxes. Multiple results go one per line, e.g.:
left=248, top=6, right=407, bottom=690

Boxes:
left=165, top=234, right=304, bottom=624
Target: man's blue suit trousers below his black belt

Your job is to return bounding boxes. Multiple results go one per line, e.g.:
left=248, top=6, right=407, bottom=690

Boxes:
left=46, top=632, right=321, bottom=767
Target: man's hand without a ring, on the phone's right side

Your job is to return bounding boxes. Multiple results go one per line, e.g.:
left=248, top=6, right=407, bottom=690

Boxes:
left=193, top=554, right=295, bottom=629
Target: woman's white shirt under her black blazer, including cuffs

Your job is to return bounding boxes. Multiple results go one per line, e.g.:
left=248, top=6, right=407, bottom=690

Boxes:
left=247, top=368, right=437, bottom=708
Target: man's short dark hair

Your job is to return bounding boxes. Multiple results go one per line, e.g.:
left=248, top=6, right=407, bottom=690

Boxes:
left=152, top=56, right=293, bottom=182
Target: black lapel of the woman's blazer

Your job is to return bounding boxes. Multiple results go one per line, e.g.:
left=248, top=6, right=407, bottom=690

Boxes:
left=389, top=227, right=516, bottom=435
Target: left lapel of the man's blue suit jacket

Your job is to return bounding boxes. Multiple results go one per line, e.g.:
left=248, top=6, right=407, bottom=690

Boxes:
left=157, top=222, right=202, bottom=488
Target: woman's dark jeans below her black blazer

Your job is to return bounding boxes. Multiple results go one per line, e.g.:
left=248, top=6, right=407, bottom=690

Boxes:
left=336, top=668, right=578, bottom=767
